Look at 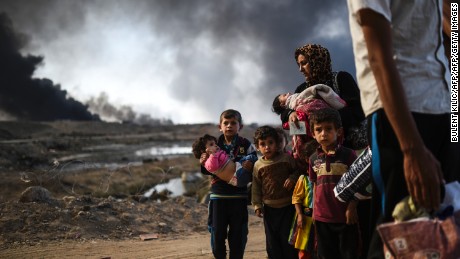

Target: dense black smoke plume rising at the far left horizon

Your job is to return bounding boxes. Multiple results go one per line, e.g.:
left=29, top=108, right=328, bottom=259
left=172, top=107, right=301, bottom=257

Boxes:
left=0, top=13, right=99, bottom=121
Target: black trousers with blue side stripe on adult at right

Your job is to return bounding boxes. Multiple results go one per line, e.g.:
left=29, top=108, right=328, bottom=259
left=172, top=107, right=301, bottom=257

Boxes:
left=368, top=110, right=460, bottom=258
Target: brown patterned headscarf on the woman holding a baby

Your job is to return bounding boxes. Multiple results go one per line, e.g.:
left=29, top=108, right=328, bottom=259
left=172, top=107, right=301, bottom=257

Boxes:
left=295, top=44, right=332, bottom=87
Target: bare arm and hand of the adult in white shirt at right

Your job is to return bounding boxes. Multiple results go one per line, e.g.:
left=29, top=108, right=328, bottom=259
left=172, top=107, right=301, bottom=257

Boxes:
left=358, top=9, right=442, bottom=209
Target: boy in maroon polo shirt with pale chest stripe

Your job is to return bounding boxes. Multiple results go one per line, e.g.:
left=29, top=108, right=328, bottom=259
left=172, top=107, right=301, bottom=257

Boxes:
left=309, top=108, right=360, bottom=259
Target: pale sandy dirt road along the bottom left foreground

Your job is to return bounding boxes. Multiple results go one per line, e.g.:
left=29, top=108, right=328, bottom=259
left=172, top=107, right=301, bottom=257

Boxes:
left=0, top=216, right=266, bottom=259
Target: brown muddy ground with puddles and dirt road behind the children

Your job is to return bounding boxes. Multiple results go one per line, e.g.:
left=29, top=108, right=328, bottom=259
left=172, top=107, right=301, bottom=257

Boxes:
left=0, top=121, right=265, bottom=258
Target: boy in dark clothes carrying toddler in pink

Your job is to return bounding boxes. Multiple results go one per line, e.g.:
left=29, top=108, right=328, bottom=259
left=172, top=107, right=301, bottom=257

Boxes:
left=200, top=109, right=257, bottom=258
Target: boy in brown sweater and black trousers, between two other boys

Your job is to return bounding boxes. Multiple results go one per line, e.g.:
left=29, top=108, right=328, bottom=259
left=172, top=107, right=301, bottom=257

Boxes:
left=252, top=126, right=299, bottom=258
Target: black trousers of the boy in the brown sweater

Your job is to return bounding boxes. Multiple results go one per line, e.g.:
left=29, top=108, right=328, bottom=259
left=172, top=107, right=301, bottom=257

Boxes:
left=264, top=205, right=298, bottom=259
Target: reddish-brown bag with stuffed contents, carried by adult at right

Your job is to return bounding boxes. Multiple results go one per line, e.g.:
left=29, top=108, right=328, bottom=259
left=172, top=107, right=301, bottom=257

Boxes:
left=377, top=182, right=460, bottom=259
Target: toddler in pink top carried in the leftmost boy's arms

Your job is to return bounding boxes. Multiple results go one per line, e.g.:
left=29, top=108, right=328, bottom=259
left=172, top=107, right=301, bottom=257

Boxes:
left=192, top=134, right=258, bottom=187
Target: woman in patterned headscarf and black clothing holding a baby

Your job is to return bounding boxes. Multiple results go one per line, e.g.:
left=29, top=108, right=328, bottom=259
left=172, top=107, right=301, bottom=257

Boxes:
left=280, top=44, right=370, bottom=258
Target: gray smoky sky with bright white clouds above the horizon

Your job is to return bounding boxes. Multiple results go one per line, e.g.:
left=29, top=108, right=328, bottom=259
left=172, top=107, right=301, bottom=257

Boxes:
left=0, top=0, right=355, bottom=124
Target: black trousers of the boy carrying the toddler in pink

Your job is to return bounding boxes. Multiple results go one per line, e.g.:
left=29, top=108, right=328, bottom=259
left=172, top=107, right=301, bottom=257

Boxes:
left=208, top=199, right=248, bottom=259
